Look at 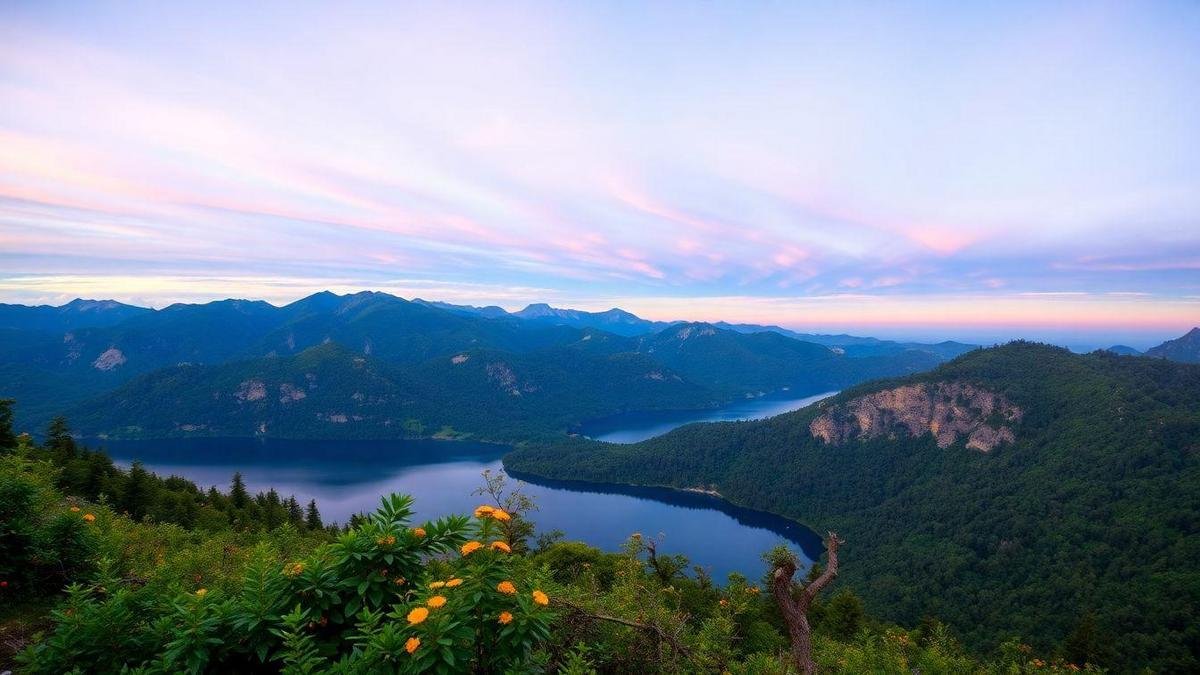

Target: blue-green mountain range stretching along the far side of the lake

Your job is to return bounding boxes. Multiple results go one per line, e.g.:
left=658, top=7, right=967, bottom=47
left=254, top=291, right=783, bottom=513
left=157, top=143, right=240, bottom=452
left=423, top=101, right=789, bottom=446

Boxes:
left=0, top=292, right=973, bottom=441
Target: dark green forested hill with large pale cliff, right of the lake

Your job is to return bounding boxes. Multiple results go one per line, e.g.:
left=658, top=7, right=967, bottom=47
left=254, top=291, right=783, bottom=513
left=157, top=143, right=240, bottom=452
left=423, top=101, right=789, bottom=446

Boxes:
left=505, top=342, right=1200, bottom=671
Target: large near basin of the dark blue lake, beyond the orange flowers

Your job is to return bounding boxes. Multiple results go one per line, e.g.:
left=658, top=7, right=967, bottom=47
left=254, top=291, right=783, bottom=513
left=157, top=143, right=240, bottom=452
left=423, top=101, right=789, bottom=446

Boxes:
left=102, top=399, right=823, bottom=581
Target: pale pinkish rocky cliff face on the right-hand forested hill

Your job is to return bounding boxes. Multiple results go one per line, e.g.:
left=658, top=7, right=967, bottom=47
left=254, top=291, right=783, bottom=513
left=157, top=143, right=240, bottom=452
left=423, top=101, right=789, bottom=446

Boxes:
left=809, top=382, right=1021, bottom=453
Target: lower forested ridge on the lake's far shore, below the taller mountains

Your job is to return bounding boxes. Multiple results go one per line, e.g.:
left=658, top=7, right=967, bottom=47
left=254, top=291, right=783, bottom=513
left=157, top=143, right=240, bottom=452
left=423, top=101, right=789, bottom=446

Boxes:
left=68, top=342, right=716, bottom=442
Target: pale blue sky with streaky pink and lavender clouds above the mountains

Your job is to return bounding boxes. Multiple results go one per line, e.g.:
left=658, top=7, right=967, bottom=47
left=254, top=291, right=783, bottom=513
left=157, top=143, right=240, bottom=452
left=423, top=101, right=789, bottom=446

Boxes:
left=0, top=0, right=1200, bottom=346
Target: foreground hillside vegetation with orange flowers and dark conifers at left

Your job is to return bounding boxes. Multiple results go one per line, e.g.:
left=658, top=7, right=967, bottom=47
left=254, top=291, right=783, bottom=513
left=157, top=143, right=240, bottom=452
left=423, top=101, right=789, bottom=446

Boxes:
left=0, top=401, right=1098, bottom=675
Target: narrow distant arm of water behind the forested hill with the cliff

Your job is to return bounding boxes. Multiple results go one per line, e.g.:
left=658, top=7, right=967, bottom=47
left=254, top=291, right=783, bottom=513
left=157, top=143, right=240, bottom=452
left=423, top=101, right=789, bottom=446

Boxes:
left=580, top=392, right=836, bottom=443
